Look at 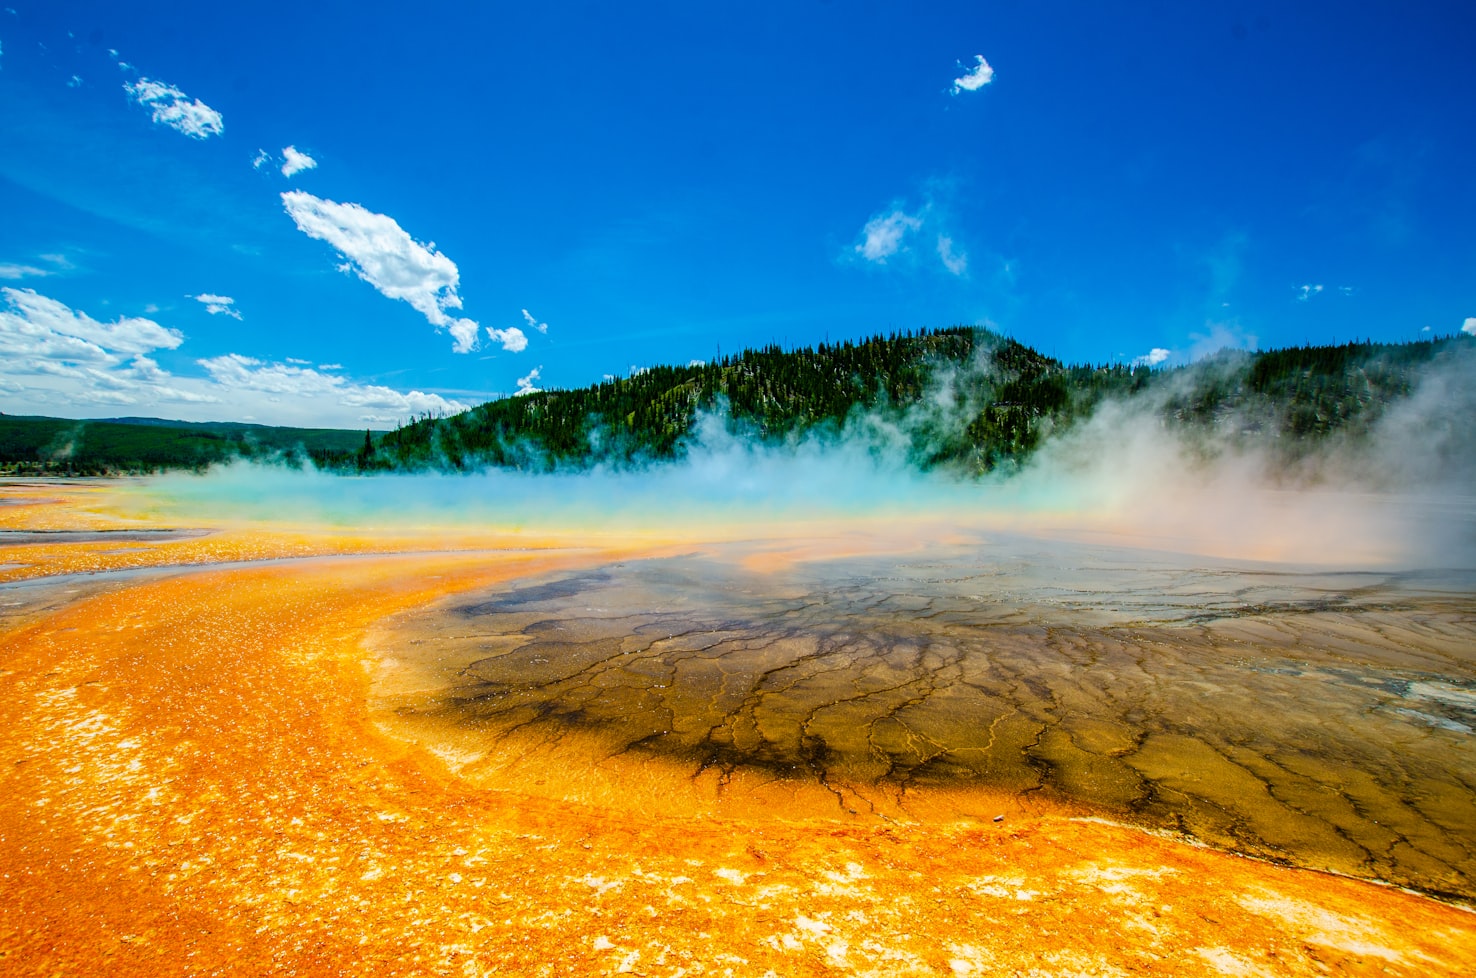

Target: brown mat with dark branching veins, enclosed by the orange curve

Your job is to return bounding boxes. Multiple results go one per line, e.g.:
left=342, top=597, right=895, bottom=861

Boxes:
left=373, top=537, right=1476, bottom=898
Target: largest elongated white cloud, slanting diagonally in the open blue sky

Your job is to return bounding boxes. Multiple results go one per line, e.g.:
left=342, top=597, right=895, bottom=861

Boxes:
left=282, top=190, right=478, bottom=353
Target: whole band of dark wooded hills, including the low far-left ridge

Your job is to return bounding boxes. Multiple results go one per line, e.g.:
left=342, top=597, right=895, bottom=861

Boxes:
left=0, top=326, right=1476, bottom=475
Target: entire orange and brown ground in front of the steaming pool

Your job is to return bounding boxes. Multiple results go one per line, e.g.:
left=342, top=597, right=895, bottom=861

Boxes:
left=0, top=482, right=1476, bottom=978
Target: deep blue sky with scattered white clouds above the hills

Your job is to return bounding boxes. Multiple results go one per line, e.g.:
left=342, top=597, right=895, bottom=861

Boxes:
left=0, top=0, right=1476, bottom=428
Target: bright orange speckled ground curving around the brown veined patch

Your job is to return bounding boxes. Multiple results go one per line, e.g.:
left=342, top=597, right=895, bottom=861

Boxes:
left=0, top=488, right=1476, bottom=978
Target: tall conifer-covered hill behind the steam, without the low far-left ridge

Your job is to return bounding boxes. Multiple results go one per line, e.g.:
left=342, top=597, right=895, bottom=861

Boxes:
left=371, top=326, right=1476, bottom=472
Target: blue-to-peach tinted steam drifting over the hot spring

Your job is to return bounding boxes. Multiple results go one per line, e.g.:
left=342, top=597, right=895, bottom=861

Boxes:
left=129, top=343, right=1476, bottom=568
